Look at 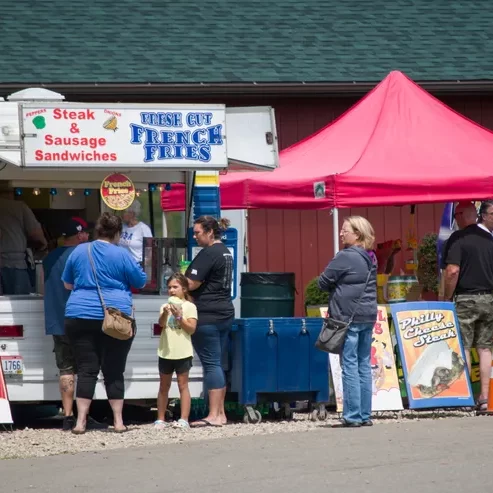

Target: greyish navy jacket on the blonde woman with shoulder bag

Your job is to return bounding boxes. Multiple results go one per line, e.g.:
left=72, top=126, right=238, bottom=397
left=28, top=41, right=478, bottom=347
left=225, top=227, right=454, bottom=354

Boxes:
left=318, top=246, right=377, bottom=323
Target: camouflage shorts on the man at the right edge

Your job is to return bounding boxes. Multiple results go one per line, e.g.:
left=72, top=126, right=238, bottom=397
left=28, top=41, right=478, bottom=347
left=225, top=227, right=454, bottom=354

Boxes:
left=455, top=294, right=493, bottom=349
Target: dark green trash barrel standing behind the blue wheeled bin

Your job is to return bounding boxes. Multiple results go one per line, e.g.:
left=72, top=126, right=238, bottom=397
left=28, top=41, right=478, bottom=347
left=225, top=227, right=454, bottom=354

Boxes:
left=240, top=272, right=296, bottom=318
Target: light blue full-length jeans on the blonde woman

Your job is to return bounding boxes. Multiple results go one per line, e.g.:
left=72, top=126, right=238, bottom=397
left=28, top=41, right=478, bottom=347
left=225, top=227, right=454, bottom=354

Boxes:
left=341, top=323, right=373, bottom=423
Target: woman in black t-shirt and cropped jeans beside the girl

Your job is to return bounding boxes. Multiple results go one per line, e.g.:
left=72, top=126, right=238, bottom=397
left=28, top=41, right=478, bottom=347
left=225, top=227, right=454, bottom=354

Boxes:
left=186, top=216, right=234, bottom=428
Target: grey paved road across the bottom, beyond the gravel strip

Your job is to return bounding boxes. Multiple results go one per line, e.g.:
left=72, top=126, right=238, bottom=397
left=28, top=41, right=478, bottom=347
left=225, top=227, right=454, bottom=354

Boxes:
left=0, top=418, right=493, bottom=493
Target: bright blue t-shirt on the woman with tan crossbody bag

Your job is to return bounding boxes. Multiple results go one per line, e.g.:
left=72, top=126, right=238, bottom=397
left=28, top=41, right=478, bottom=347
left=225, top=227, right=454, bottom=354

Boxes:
left=62, top=240, right=146, bottom=320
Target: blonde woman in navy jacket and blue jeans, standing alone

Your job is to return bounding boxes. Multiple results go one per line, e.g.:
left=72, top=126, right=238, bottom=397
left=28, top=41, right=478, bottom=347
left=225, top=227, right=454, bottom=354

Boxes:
left=318, top=216, right=377, bottom=427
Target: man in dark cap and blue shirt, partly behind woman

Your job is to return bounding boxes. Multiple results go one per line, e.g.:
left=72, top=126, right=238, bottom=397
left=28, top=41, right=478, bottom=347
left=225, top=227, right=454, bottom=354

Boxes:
left=43, top=217, right=89, bottom=431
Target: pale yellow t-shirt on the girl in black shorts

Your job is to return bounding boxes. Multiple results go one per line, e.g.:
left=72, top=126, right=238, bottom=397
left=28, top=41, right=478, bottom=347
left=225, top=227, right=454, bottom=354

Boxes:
left=157, top=301, right=197, bottom=359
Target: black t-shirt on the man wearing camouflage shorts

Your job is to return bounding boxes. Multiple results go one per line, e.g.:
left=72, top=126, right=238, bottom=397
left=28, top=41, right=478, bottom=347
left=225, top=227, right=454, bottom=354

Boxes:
left=445, top=224, right=493, bottom=294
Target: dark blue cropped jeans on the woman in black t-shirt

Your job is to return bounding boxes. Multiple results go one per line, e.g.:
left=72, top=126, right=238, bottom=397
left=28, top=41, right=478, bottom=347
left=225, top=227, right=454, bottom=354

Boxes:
left=192, top=319, right=233, bottom=390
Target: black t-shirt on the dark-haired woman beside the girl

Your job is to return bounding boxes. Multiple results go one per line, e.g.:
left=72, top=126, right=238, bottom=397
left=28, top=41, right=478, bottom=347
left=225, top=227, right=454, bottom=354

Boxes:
left=186, top=243, right=234, bottom=325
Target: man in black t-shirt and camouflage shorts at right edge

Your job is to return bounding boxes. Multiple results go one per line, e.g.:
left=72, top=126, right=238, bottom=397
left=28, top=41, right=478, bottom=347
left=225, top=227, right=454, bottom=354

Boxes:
left=444, top=200, right=493, bottom=411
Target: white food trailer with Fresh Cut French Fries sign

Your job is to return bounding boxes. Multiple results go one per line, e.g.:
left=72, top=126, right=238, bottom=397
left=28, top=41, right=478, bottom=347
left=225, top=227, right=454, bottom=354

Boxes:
left=0, top=88, right=278, bottom=402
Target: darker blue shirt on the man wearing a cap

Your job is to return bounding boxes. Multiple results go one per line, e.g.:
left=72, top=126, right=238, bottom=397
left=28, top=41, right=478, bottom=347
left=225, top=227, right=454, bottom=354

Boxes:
left=43, top=247, right=75, bottom=336
